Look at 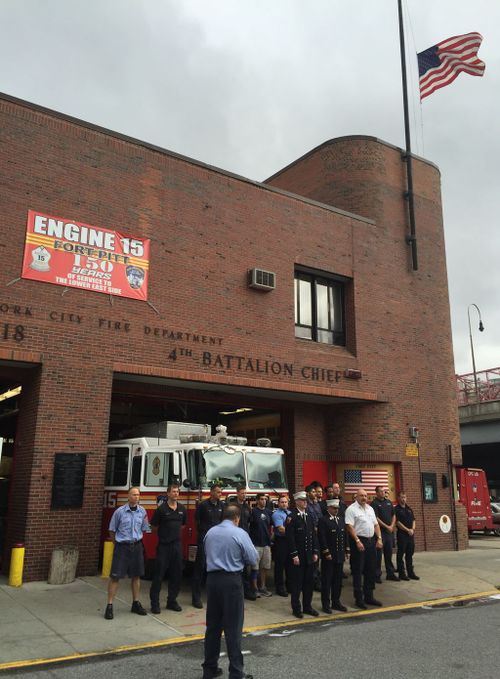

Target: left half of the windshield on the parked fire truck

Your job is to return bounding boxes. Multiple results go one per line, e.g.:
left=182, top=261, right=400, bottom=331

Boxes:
left=188, top=448, right=245, bottom=488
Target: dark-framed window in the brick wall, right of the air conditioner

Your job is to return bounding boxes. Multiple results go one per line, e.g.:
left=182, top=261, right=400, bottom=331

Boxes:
left=295, top=271, right=345, bottom=346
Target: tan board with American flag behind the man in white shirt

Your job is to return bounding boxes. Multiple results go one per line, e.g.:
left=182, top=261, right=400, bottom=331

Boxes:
left=335, top=462, right=396, bottom=502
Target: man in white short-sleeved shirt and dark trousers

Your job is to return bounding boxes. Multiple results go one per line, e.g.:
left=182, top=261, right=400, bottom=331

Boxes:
left=345, top=488, right=382, bottom=609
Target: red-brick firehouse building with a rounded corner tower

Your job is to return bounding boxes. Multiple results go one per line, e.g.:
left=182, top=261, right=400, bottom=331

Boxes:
left=0, top=96, right=466, bottom=579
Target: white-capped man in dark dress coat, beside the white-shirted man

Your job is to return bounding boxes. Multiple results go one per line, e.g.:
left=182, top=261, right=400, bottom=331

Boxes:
left=318, top=500, right=347, bottom=614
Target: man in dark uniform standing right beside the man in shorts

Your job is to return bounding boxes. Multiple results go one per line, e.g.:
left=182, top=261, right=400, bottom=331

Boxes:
left=149, top=483, right=187, bottom=614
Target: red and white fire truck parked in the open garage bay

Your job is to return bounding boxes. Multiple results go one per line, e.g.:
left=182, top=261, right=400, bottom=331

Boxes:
left=102, top=421, right=288, bottom=574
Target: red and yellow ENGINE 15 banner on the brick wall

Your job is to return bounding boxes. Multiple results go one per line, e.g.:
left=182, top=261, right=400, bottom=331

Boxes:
left=21, top=210, right=150, bottom=301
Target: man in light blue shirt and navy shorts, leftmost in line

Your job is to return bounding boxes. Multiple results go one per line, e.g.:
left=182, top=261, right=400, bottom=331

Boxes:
left=104, top=487, right=150, bottom=620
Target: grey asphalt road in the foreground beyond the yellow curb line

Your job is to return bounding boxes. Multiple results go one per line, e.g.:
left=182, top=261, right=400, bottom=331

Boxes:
left=4, top=595, right=500, bottom=679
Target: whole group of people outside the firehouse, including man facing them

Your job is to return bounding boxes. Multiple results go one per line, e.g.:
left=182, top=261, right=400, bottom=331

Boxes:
left=104, top=483, right=419, bottom=679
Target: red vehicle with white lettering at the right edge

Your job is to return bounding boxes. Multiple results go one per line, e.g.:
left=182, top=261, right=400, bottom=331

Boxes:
left=457, top=467, right=500, bottom=536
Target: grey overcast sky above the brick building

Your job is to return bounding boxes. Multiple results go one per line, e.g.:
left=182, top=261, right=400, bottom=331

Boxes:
left=0, top=0, right=500, bottom=373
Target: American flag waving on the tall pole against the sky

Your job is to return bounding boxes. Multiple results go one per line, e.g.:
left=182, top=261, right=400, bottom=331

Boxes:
left=417, top=33, right=486, bottom=99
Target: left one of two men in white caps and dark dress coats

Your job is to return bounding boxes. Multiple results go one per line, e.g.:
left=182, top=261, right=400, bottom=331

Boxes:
left=285, top=491, right=319, bottom=618
